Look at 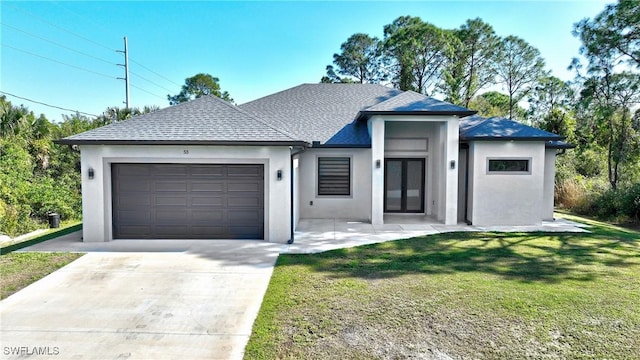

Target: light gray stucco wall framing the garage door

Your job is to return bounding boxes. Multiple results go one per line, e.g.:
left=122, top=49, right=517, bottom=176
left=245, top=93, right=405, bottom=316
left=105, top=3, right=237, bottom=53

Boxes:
left=80, top=145, right=291, bottom=242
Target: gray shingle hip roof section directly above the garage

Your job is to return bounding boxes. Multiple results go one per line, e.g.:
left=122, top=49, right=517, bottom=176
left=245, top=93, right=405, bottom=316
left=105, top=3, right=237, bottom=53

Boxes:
left=59, top=96, right=299, bottom=144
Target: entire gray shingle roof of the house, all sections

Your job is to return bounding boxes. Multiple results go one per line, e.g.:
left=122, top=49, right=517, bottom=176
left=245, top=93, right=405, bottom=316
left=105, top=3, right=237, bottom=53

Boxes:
left=57, top=84, right=564, bottom=146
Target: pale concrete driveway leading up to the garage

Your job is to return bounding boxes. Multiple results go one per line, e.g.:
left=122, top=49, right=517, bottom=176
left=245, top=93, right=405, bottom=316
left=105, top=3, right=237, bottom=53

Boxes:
left=0, top=241, right=281, bottom=359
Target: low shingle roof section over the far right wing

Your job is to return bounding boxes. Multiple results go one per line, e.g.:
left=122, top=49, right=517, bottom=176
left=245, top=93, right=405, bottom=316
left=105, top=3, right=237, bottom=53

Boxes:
left=460, top=117, right=563, bottom=141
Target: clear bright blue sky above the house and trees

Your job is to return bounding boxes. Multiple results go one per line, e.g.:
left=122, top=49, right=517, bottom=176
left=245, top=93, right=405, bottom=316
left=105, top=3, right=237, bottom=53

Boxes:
left=0, top=0, right=610, bottom=121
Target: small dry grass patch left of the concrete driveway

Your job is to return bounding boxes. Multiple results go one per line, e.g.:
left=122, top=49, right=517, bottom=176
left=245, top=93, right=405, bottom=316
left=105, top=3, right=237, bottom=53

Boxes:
left=0, top=252, right=83, bottom=299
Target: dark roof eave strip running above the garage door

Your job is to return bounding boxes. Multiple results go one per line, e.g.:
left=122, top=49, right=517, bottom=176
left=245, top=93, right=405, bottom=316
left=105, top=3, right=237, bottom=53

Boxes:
left=53, top=139, right=309, bottom=147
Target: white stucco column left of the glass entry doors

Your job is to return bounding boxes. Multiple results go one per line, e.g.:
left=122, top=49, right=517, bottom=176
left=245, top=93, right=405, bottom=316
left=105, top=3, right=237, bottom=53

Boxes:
left=368, top=116, right=384, bottom=225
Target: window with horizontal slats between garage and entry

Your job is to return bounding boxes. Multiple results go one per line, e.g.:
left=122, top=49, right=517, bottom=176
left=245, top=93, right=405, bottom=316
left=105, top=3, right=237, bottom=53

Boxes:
left=318, top=157, right=351, bottom=196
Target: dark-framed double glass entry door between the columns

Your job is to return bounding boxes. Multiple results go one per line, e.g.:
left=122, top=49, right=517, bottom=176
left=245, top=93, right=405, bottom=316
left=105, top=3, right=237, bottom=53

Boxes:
left=384, top=159, right=424, bottom=213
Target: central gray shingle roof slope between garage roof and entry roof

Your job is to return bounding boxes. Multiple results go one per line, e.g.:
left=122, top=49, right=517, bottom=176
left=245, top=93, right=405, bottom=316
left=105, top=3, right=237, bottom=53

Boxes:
left=239, top=84, right=402, bottom=144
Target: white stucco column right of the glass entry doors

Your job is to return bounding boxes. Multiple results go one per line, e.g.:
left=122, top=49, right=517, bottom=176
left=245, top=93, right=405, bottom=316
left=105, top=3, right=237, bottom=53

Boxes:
left=443, top=117, right=460, bottom=225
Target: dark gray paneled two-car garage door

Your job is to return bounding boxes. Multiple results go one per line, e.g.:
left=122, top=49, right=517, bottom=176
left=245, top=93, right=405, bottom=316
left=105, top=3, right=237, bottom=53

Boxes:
left=111, top=164, right=264, bottom=239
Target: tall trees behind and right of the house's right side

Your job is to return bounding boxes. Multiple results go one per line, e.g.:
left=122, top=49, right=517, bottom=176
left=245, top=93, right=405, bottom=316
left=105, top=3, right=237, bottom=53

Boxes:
left=320, top=0, right=640, bottom=221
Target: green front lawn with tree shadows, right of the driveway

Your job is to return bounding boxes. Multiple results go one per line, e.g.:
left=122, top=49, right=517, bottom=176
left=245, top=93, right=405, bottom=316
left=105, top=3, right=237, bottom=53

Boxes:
left=245, top=215, right=640, bottom=359
